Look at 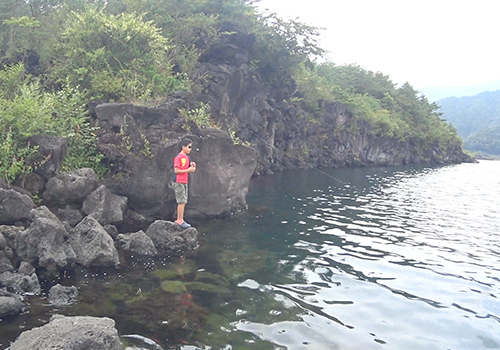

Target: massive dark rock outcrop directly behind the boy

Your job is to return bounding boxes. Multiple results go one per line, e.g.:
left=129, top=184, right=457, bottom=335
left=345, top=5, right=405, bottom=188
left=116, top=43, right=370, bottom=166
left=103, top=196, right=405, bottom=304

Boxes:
left=95, top=102, right=256, bottom=222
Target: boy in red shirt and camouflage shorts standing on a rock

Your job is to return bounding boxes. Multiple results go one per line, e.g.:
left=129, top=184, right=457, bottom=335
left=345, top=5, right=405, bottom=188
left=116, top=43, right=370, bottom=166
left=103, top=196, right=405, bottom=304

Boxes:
left=172, top=139, right=196, bottom=228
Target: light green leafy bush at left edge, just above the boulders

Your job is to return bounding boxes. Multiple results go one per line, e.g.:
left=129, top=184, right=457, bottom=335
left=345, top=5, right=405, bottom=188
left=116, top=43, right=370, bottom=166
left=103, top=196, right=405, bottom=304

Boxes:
left=0, top=64, right=106, bottom=183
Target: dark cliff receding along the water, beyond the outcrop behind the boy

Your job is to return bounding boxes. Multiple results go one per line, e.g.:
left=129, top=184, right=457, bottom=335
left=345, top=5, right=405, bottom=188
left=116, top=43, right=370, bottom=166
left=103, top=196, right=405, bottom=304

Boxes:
left=199, top=28, right=470, bottom=175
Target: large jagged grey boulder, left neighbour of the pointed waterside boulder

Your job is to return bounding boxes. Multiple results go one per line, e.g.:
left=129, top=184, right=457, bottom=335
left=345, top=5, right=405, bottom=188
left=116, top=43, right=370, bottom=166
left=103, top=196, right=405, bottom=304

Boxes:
left=15, top=206, right=76, bottom=273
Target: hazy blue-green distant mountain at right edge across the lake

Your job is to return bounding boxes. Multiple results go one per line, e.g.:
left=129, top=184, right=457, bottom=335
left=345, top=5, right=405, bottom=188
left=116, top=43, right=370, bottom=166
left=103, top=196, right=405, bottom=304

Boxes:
left=437, top=90, right=500, bottom=155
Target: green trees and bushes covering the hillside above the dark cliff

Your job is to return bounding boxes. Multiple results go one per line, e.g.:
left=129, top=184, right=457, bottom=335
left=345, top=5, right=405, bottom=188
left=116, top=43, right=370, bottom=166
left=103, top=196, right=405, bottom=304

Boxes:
left=0, top=0, right=464, bottom=186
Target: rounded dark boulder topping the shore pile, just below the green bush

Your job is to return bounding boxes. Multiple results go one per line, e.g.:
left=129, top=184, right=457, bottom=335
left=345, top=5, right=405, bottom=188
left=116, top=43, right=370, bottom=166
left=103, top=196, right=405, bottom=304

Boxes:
left=43, top=168, right=99, bottom=208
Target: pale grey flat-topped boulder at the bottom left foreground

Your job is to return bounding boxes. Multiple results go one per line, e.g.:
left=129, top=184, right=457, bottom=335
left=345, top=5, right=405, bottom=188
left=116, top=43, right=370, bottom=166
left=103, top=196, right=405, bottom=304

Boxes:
left=10, top=315, right=122, bottom=350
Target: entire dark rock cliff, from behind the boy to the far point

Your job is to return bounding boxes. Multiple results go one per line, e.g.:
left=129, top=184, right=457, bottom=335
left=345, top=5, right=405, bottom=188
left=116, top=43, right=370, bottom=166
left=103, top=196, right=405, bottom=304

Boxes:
left=95, top=26, right=467, bottom=218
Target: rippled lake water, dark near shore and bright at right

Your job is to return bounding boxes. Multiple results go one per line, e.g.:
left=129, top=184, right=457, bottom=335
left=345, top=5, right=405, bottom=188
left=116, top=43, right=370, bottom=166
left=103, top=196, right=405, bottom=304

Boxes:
left=0, top=161, right=500, bottom=350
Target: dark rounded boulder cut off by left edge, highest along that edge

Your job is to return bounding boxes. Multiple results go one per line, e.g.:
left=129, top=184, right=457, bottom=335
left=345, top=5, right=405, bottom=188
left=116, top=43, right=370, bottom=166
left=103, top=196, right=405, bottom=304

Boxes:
left=0, top=188, right=35, bottom=224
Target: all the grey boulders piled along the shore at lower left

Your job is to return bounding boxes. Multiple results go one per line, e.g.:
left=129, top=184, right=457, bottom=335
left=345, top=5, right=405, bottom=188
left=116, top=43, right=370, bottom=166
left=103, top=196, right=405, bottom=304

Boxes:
left=0, top=169, right=198, bottom=349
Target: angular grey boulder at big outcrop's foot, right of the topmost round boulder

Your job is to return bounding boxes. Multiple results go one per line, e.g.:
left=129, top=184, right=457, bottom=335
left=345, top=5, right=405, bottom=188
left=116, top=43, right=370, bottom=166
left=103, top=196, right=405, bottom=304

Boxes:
left=82, top=185, right=127, bottom=225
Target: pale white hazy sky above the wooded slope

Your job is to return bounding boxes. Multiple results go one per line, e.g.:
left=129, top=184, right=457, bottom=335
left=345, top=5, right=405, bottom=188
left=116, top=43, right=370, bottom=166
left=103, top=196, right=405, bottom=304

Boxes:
left=259, top=0, right=500, bottom=88
